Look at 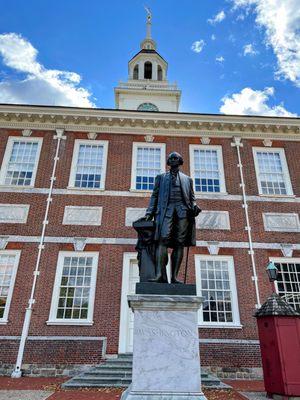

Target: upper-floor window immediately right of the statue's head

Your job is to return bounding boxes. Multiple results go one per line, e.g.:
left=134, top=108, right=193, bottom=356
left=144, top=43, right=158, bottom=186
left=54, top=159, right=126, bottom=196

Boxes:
left=190, top=145, right=226, bottom=193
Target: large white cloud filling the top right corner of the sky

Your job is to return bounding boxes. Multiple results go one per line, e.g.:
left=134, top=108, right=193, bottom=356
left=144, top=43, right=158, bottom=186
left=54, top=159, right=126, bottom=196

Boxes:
left=232, top=0, right=300, bottom=86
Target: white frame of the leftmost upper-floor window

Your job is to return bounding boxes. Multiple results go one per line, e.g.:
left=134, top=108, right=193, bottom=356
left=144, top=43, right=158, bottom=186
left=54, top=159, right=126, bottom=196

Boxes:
left=0, top=136, right=43, bottom=189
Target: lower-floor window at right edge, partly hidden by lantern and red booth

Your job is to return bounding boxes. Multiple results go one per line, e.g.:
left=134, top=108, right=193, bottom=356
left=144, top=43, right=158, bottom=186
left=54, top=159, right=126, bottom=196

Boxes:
left=271, top=258, right=300, bottom=311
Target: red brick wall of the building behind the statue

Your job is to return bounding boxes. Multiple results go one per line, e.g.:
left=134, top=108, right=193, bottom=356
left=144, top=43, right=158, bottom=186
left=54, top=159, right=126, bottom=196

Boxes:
left=0, top=129, right=300, bottom=366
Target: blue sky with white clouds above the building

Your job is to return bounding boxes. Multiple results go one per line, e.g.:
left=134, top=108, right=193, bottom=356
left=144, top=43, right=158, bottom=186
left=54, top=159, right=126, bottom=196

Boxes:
left=0, top=0, right=300, bottom=117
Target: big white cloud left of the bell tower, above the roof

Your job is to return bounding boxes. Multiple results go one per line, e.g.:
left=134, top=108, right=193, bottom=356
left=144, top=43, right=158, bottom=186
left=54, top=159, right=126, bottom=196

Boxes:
left=0, top=33, right=95, bottom=107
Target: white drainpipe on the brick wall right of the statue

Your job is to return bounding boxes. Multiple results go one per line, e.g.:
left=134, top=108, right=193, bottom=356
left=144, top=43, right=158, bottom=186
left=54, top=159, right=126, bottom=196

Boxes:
left=231, top=137, right=261, bottom=308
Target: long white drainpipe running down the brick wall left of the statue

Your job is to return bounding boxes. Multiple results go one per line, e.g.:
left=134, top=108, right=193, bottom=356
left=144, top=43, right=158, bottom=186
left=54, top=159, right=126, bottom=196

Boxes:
left=11, top=129, right=66, bottom=378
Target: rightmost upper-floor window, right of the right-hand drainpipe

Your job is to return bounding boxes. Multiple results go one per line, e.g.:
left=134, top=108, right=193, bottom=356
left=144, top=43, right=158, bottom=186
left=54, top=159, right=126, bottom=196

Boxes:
left=253, top=148, right=293, bottom=195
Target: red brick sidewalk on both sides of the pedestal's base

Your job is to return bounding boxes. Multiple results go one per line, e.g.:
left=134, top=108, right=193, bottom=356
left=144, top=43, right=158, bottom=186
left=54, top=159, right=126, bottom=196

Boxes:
left=0, top=377, right=265, bottom=400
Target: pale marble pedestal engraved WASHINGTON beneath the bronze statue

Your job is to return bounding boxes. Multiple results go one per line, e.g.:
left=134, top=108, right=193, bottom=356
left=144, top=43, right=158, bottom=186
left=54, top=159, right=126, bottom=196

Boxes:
left=122, top=294, right=206, bottom=400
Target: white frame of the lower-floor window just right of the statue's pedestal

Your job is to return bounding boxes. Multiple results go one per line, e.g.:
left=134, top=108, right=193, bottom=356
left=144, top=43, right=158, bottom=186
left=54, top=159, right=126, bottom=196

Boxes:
left=195, top=254, right=242, bottom=329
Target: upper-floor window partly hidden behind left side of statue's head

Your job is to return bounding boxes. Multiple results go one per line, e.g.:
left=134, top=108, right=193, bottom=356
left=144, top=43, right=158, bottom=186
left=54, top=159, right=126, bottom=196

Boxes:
left=131, top=143, right=165, bottom=190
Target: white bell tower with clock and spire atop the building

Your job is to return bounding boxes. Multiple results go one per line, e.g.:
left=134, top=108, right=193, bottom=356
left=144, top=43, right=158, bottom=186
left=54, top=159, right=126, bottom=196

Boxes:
left=115, top=8, right=181, bottom=112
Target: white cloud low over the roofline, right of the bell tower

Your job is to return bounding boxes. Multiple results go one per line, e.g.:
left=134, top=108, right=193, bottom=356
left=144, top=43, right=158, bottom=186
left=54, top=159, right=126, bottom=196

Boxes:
left=220, top=87, right=297, bottom=117
